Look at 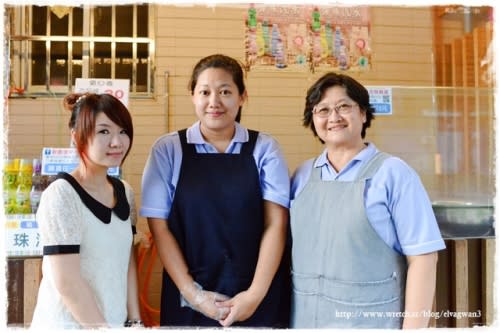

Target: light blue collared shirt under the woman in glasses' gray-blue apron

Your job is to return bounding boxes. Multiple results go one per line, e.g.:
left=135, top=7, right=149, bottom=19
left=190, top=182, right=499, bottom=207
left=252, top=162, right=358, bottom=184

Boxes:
left=291, top=143, right=445, bottom=255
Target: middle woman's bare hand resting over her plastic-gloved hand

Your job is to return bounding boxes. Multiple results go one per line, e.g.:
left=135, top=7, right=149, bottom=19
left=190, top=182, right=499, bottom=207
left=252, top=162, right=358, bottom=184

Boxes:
left=216, top=290, right=261, bottom=327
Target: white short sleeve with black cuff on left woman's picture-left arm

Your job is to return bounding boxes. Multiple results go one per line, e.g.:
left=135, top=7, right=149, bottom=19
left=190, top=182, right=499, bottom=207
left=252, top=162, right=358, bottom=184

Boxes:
left=36, top=179, right=83, bottom=254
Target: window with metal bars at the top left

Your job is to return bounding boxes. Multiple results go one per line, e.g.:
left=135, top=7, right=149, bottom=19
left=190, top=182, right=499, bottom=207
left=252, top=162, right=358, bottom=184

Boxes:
left=6, top=4, right=155, bottom=96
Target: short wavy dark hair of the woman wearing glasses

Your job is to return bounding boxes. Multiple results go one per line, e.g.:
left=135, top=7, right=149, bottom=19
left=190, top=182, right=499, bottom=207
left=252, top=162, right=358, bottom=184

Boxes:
left=302, top=72, right=375, bottom=143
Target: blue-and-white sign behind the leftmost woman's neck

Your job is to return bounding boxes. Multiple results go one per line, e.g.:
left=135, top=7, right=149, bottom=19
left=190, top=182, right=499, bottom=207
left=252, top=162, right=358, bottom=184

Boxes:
left=42, top=147, right=120, bottom=177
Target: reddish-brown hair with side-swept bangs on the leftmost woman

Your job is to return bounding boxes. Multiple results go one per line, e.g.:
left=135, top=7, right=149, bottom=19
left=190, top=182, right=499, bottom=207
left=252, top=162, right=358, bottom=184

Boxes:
left=63, top=93, right=134, bottom=163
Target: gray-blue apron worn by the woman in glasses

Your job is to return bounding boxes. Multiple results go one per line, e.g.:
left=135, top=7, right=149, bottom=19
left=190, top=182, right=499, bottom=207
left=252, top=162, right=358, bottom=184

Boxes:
left=290, top=152, right=407, bottom=328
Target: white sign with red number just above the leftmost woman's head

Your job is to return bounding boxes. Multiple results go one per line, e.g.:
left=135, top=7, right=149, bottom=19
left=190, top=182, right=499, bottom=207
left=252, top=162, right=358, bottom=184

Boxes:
left=75, top=79, right=130, bottom=107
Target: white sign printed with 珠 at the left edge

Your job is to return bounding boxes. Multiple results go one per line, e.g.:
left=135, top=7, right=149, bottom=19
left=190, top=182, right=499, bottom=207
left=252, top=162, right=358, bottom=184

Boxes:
left=4, top=214, right=42, bottom=257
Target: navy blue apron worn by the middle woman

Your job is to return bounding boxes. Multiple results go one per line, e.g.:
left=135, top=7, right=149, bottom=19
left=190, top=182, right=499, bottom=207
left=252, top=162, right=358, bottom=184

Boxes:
left=156, top=129, right=290, bottom=327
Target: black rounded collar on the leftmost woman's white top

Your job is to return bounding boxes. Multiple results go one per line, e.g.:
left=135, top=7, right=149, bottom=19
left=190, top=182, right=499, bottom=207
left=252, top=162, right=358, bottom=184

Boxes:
left=57, top=172, right=130, bottom=224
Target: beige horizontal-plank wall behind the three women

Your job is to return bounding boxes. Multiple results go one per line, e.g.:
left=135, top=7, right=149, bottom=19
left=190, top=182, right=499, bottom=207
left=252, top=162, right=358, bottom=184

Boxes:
left=5, top=4, right=496, bottom=328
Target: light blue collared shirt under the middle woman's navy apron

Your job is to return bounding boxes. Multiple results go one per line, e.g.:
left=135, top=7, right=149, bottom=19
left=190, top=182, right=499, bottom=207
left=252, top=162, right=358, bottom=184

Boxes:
left=139, top=121, right=290, bottom=219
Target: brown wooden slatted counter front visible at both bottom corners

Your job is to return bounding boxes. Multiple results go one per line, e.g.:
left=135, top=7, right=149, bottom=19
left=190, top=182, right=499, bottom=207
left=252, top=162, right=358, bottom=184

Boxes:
left=7, top=239, right=496, bottom=328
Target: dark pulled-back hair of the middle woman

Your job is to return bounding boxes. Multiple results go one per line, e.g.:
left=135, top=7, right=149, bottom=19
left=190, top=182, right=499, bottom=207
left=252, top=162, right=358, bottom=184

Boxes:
left=188, top=54, right=246, bottom=122
